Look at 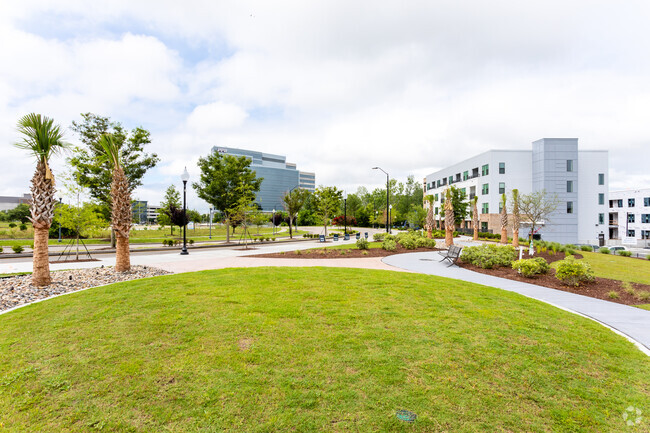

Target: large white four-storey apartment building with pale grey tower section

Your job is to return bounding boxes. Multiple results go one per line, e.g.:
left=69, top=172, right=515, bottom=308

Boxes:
left=424, top=138, right=609, bottom=244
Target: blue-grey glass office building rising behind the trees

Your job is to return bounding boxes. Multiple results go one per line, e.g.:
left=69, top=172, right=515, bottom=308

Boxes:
left=212, top=146, right=316, bottom=212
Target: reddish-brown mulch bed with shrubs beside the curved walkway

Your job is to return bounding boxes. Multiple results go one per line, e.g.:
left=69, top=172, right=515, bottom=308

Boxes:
left=457, top=248, right=650, bottom=305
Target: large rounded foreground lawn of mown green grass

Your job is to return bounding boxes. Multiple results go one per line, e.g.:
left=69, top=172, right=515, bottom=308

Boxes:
left=0, top=268, right=650, bottom=432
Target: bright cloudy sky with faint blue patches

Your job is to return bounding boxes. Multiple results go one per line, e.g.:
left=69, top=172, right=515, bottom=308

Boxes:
left=0, top=0, right=650, bottom=210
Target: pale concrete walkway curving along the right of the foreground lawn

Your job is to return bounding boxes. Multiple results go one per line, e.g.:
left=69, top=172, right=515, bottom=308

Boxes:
left=382, top=252, right=650, bottom=356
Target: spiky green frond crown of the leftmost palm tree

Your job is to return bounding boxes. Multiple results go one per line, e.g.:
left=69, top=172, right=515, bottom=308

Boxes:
left=15, top=113, right=70, bottom=162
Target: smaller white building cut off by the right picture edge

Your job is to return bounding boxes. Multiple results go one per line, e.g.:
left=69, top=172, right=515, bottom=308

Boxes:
left=607, top=188, right=650, bottom=247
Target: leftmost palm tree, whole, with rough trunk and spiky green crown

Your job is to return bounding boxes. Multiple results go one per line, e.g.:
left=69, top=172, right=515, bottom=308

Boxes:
left=15, top=113, right=68, bottom=287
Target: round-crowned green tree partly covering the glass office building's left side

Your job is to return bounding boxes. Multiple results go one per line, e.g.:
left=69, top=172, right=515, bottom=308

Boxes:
left=192, top=152, right=263, bottom=242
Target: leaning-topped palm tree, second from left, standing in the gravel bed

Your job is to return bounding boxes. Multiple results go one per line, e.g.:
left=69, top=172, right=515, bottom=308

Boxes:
left=99, top=134, right=133, bottom=272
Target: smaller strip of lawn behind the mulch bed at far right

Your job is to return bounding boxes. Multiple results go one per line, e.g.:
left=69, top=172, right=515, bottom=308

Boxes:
left=579, top=251, right=650, bottom=284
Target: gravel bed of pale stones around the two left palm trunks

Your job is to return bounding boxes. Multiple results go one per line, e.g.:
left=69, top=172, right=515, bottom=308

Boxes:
left=0, top=266, right=170, bottom=311
